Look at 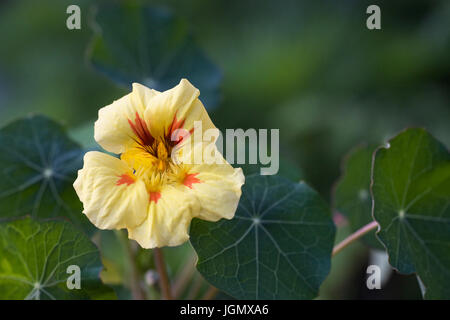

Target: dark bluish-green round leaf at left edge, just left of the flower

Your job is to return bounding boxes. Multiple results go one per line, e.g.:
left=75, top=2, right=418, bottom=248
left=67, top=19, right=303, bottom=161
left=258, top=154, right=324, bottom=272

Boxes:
left=0, top=116, right=92, bottom=230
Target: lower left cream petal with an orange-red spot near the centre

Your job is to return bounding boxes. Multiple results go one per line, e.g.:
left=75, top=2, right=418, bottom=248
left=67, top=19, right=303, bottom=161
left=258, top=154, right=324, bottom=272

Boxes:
left=73, top=151, right=149, bottom=229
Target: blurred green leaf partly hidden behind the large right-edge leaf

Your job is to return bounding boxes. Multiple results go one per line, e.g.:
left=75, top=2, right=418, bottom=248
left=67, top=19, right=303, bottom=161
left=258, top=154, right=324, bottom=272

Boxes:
left=334, top=145, right=384, bottom=249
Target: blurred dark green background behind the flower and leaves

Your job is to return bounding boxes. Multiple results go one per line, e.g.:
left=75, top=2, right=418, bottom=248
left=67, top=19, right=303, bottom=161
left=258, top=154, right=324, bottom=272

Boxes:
left=0, top=0, right=450, bottom=298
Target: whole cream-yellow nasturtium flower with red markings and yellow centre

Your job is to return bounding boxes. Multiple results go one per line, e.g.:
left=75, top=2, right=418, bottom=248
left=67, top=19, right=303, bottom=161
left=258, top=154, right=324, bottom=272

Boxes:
left=74, top=79, right=244, bottom=248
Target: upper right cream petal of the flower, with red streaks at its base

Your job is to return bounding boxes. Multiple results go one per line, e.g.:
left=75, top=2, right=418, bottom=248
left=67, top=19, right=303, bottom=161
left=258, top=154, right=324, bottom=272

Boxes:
left=145, top=79, right=215, bottom=140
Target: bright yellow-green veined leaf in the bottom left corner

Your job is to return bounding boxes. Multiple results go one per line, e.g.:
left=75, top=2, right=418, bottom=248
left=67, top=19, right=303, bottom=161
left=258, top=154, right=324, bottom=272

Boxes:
left=0, top=217, right=114, bottom=300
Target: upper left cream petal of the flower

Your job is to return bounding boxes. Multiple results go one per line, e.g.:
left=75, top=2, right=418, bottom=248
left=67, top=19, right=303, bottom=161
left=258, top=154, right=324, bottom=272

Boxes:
left=94, top=83, right=159, bottom=154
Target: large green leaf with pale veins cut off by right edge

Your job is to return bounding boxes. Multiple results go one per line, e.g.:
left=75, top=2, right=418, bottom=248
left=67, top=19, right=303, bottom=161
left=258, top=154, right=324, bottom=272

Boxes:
left=372, top=129, right=450, bottom=299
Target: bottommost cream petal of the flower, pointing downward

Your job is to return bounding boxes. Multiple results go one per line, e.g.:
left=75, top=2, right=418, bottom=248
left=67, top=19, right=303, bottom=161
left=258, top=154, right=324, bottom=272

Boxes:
left=128, top=186, right=199, bottom=249
